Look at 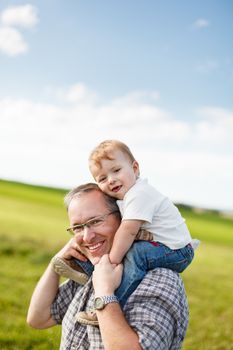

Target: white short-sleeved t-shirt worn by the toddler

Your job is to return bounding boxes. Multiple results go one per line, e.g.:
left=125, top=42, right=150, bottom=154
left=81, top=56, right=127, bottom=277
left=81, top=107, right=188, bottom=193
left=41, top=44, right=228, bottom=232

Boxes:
left=117, top=179, right=192, bottom=249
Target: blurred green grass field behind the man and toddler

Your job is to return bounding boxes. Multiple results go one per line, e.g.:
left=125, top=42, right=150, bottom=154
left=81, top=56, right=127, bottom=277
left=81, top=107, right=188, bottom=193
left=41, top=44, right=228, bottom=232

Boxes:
left=0, top=181, right=233, bottom=350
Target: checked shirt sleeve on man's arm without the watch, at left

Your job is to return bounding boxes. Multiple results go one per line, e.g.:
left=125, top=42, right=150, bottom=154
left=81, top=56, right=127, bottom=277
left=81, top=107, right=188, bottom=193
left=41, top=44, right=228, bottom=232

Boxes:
left=50, top=280, right=79, bottom=324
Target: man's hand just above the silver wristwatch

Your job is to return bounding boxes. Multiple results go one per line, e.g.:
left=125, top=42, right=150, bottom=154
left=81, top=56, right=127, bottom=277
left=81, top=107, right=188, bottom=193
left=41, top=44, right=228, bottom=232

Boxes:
left=92, top=254, right=123, bottom=296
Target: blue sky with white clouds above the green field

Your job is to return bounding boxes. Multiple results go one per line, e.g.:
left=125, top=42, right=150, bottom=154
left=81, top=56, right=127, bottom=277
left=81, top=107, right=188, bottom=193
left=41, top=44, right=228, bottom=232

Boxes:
left=0, top=0, right=233, bottom=211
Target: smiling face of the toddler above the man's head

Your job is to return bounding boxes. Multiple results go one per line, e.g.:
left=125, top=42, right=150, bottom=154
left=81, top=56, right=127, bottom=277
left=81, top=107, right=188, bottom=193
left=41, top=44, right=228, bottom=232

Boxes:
left=90, top=150, right=139, bottom=199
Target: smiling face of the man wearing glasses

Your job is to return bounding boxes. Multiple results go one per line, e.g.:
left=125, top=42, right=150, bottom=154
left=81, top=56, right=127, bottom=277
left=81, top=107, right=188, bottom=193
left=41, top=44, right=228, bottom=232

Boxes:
left=68, top=191, right=120, bottom=262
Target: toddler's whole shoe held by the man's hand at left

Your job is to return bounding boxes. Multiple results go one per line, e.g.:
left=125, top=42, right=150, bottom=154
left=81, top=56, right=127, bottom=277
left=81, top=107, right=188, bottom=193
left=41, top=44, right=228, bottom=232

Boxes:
left=51, top=256, right=89, bottom=284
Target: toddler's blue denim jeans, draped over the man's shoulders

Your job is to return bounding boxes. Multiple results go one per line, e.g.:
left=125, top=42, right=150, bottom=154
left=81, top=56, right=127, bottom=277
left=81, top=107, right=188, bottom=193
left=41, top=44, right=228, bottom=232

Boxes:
left=73, top=241, right=194, bottom=307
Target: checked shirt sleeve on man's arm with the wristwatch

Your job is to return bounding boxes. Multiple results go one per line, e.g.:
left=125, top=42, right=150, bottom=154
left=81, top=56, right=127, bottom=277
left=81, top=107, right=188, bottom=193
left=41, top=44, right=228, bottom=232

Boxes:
left=124, top=268, right=188, bottom=350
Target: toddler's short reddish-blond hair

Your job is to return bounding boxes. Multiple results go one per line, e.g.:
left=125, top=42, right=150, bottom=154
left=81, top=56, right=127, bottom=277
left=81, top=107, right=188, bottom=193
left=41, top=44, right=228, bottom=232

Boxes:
left=89, top=140, right=135, bottom=167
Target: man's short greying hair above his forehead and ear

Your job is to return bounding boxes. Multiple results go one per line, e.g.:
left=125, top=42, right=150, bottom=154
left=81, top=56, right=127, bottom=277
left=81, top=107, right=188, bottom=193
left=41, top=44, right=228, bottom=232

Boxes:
left=64, top=182, right=120, bottom=217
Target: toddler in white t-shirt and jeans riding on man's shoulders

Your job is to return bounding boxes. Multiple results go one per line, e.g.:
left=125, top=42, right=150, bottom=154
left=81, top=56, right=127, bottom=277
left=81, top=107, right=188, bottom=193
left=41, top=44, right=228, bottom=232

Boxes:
left=52, top=140, right=197, bottom=324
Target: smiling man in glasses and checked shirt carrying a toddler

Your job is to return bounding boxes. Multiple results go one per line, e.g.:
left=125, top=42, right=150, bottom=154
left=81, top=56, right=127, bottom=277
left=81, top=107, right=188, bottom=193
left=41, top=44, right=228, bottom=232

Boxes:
left=27, top=184, right=188, bottom=350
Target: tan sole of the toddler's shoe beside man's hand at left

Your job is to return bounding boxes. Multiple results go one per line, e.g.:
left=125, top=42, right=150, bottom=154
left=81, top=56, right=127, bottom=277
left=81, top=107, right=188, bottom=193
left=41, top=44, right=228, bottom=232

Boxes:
left=51, top=256, right=89, bottom=285
